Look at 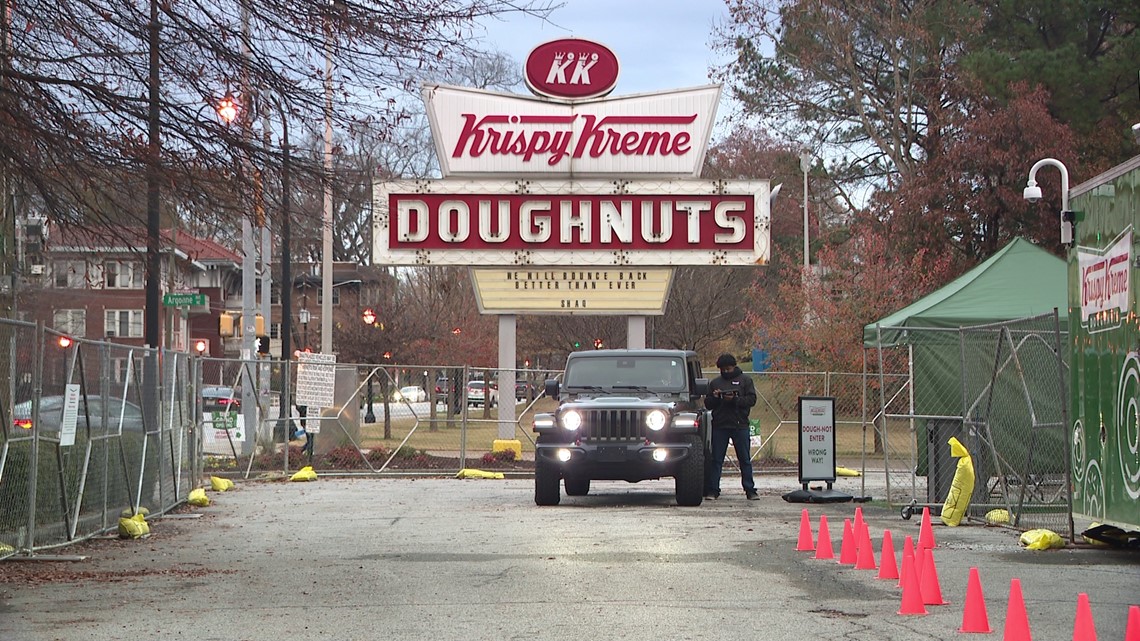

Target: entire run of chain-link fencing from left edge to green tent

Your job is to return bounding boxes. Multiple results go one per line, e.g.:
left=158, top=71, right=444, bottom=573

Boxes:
left=0, top=316, right=1072, bottom=554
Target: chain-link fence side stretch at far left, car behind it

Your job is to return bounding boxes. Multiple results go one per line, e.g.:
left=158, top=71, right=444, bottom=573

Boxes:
left=0, top=321, right=197, bottom=554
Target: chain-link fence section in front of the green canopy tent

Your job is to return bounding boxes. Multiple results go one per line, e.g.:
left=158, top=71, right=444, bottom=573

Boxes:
left=877, top=313, right=1074, bottom=538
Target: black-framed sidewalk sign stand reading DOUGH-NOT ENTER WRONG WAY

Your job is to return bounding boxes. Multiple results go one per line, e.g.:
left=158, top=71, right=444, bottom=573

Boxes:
left=783, top=396, right=852, bottom=503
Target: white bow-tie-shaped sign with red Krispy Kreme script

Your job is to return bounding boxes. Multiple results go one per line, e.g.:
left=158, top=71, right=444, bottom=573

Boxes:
left=424, top=86, right=720, bottom=178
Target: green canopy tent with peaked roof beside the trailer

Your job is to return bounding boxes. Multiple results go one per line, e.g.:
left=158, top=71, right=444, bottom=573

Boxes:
left=863, top=238, right=1068, bottom=510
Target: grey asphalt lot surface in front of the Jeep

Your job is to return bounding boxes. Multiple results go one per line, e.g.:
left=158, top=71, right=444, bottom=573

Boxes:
left=0, top=477, right=1140, bottom=641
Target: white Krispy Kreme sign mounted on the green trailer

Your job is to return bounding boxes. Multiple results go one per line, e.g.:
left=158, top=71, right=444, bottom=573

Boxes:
left=1076, top=227, right=1132, bottom=333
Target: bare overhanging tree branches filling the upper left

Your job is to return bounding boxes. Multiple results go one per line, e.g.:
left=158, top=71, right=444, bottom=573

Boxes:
left=0, top=0, right=548, bottom=244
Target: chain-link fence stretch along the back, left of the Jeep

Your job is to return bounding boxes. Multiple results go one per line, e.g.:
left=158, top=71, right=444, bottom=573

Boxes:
left=209, top=359, right=557, bottom=474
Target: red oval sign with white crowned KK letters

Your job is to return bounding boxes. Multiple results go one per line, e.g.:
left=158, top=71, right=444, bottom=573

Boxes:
left=524, top=38, right=618, bottom=100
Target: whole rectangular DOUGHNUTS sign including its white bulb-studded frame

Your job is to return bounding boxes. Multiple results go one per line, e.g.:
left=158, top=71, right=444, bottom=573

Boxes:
left=373, top=180, right=770, bottom=266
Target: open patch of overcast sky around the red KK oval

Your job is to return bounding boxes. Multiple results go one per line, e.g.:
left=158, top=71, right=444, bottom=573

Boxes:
left=474, top=0, right=728, bottom=97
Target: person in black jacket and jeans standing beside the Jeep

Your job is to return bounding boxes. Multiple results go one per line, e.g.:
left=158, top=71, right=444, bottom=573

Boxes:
left=705, top=354, right=759, bottom=501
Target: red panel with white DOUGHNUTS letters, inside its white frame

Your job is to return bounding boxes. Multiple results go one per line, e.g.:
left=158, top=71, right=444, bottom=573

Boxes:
left=388, top=194, right=756, bottom=250
